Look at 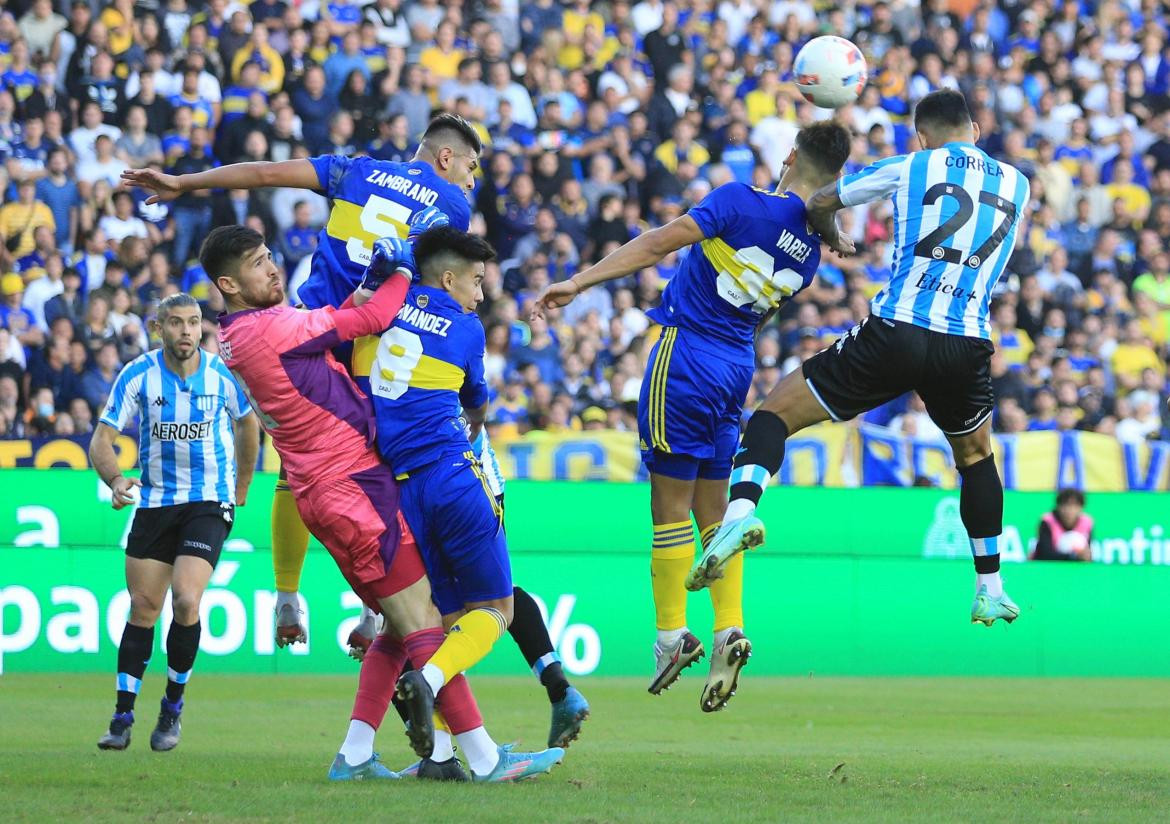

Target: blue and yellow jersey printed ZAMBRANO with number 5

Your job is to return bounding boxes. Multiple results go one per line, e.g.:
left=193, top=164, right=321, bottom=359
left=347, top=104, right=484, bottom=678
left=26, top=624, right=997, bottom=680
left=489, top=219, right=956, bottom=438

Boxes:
left=298, top=155, right=472, bottom=309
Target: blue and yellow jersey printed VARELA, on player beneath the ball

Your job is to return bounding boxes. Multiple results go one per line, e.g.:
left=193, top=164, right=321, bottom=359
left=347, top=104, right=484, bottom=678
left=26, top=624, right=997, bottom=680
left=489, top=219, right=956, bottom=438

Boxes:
left=649, top=183, right=820, bottom=364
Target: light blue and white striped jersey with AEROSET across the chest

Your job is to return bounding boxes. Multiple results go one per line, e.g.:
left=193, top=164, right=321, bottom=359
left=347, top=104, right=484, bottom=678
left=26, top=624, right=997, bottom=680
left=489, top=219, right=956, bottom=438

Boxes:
left=101, top=349, right=252, bottom=509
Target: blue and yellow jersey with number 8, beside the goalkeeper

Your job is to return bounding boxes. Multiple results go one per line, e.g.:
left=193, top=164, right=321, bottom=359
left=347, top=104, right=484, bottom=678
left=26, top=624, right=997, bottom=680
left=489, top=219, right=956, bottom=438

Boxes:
left=369, top=286, right=488, bottom=474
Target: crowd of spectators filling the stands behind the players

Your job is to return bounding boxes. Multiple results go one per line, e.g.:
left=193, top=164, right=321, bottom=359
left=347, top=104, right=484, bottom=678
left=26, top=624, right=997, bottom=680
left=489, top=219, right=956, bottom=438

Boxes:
left=0, top=0, right=1170, bottom=449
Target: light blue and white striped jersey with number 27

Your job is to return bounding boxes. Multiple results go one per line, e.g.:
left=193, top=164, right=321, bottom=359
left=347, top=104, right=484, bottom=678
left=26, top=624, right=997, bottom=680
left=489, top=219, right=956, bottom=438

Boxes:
left=837, top=143, right=1030, bottom=338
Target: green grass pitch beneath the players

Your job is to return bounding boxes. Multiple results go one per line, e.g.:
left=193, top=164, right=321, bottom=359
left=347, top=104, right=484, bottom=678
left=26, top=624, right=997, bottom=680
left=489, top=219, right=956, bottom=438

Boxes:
left=0, top=668, right=1170, bottom=824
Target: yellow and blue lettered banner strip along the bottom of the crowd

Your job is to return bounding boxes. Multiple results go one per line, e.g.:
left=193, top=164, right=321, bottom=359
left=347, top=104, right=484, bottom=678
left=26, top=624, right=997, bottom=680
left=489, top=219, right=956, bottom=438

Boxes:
left=0, top=424, right=1170, bottom=492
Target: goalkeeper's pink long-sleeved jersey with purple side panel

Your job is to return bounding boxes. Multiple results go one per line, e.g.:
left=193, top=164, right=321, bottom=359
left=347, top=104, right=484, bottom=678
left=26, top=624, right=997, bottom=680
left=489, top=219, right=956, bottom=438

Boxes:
left=219, top=277, right=408, bottom=492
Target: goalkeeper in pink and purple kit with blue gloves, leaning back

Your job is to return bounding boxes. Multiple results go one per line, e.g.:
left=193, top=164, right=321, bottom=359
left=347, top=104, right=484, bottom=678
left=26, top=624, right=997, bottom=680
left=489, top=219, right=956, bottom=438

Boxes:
left=200, top=225, right=564, bottom=781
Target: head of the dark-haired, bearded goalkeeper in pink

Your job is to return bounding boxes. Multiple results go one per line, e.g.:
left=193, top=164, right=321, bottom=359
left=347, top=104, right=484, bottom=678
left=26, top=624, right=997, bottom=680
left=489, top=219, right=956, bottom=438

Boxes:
left=199, top=224, right=284, bottom=311
